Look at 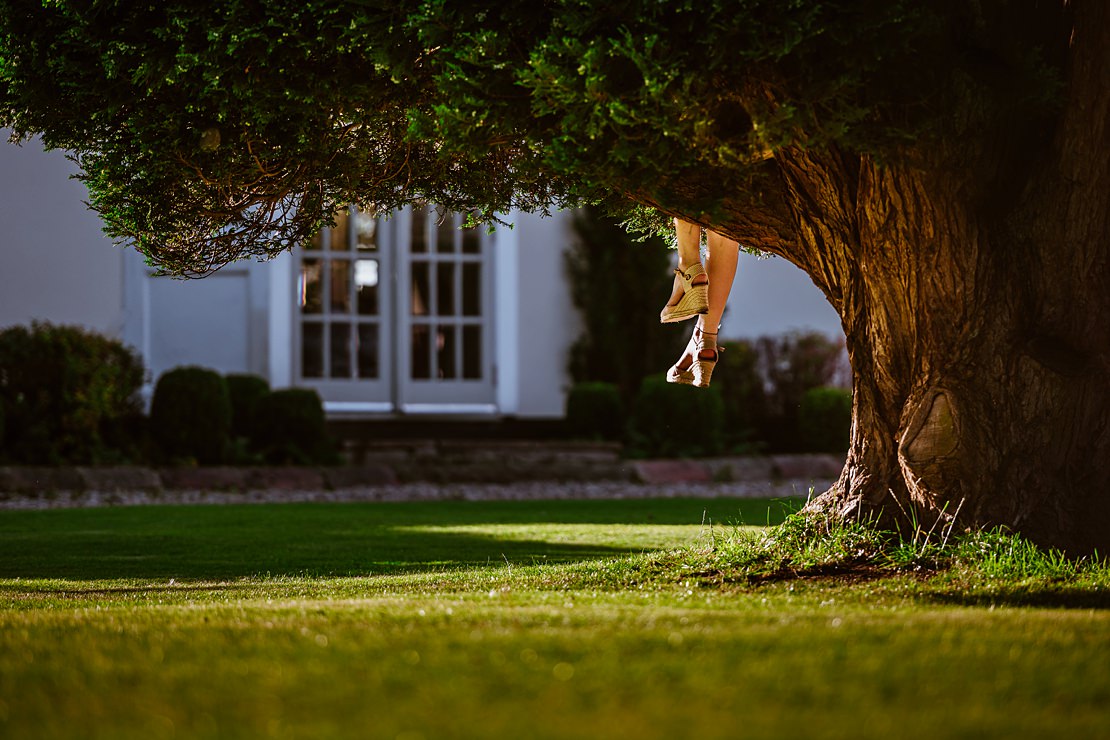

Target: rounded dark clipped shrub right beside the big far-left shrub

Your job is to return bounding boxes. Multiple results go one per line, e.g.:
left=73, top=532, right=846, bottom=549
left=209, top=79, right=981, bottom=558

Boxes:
left=150, top=366, right=231, bottom=465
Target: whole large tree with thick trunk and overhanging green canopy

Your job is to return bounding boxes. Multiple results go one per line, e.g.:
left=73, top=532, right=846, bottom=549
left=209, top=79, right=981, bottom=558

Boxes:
left=0, top=0, right=1110, bottom=551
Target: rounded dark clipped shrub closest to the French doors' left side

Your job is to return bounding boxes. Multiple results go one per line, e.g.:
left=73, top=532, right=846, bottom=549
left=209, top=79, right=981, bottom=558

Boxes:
left=251, top=388, right=340, bottom=465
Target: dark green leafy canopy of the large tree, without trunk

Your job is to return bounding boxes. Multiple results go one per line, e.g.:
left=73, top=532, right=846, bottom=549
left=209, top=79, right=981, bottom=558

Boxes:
left=0, top=0, right=1053, bottom=273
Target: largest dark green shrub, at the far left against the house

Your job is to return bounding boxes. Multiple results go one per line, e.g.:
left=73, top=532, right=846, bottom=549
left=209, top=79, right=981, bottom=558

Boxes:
left=0, top=323, right=144, bottom=465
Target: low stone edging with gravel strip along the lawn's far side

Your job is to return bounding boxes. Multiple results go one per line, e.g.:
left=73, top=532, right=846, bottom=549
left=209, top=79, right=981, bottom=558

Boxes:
left=0, top=440, right=844, bottom=508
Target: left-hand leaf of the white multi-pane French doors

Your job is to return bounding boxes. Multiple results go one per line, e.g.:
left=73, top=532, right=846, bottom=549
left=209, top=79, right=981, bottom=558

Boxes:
left=295, top=207, right=393, bottom=410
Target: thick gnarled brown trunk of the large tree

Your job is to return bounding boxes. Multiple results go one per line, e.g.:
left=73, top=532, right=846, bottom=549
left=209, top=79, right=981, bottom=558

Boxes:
left=713, top=2, right=1110, bottom=553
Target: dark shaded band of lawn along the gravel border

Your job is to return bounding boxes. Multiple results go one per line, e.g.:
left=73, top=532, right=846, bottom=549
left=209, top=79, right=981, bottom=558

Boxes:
left=0, top=499, right=787, bottom=580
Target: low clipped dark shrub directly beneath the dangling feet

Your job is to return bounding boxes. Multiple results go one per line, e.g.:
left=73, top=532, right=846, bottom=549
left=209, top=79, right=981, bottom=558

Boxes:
left=628, top=376, right=725, bottom=457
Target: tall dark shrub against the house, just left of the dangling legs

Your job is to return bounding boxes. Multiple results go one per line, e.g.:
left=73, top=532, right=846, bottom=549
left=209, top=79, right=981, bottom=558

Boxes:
left=566, top=209, right=689, bottom=405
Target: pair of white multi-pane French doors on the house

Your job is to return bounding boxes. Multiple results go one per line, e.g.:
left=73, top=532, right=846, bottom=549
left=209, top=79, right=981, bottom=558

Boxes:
left=296, top=207, right=496, bottom=414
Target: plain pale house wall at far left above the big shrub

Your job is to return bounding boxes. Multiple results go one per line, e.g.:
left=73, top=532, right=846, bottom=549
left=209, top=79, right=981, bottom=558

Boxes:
left=0, top=134, right=124, bottom=336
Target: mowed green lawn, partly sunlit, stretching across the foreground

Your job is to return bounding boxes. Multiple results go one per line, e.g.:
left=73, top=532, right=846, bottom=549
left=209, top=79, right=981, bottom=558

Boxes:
left=0, top=499, right=1110, bottom=740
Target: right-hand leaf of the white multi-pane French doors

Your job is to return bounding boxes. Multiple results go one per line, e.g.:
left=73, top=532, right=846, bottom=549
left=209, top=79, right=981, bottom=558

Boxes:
left=396, top=207, right=496, bottom=413
